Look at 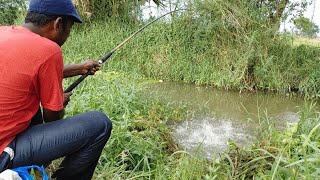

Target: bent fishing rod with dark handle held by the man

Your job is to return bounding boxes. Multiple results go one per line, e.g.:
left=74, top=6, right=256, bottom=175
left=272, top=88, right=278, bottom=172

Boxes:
left=64, top=9, right=185, bottom=93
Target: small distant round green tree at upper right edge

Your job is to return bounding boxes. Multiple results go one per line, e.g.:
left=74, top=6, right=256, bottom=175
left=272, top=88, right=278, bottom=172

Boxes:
left=293, top=17, right=319, bottom=38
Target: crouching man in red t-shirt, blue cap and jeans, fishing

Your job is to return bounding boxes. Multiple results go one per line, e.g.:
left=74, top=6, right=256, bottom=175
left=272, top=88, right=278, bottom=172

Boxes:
left=0, top=0, right=112, bottom=179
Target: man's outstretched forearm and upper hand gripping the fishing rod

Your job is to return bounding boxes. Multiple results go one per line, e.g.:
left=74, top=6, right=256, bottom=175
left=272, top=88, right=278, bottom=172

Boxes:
left=63, top=60, right=101, bottom=78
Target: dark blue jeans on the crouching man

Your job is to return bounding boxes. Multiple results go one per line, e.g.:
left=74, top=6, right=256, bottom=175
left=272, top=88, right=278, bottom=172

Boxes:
left=10, top=111, right=112, bottom=180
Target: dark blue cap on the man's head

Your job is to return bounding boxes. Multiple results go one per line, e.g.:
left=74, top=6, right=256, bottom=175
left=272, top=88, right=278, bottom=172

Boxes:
left=29, top=0, right=82, bottom=23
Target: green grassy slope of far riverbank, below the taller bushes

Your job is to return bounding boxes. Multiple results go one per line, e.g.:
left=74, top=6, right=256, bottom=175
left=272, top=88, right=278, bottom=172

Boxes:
left=64, top=20, right=320, bottom=99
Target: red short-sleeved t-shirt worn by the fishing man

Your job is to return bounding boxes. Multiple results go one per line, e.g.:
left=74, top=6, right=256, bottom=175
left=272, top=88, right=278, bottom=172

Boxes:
left=0, top=26, right=63, bottom=154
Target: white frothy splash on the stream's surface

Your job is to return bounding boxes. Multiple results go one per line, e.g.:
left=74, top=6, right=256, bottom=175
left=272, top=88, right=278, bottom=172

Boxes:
left=173, top=117, right=255, bottom=159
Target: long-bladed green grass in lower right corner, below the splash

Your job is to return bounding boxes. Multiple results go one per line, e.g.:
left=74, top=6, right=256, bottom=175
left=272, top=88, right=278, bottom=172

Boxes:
left=159, top=105, right=320, bottom=179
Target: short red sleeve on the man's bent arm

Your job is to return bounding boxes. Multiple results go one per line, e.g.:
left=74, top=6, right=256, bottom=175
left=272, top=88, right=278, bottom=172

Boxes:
left=38, top=51, right=64, bottom=111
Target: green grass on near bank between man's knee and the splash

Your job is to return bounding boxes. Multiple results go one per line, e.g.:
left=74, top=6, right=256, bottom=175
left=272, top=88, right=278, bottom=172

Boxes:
left=62, top=71, right=184, bottom=179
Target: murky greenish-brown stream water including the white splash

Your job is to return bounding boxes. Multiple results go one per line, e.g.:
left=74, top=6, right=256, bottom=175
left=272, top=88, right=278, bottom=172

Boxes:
left=147, top=83, right=318, bottom=158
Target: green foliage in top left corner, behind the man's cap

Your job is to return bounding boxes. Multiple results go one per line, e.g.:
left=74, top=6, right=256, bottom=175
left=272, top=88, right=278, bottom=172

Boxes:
left=0, top=0, right=25, bottom=25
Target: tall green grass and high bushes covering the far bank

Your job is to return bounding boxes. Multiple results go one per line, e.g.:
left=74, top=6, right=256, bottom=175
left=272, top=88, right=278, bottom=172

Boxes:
left=67, top=0, right=320, bottom=98
